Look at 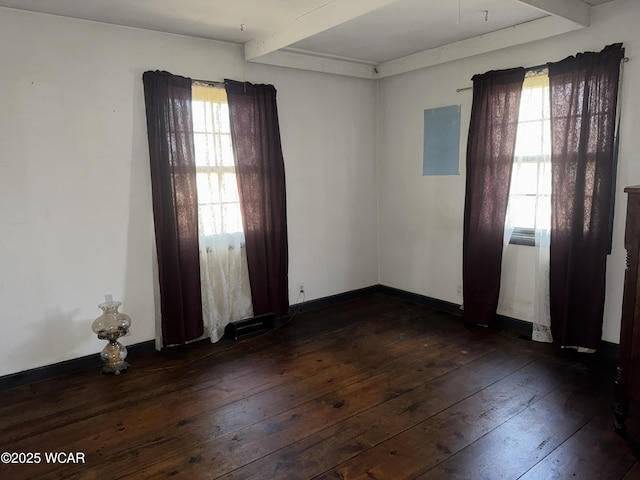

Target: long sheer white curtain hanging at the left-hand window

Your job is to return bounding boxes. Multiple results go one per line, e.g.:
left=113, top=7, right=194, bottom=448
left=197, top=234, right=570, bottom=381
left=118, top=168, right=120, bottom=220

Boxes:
left=192, top=84, right=253, bottom=342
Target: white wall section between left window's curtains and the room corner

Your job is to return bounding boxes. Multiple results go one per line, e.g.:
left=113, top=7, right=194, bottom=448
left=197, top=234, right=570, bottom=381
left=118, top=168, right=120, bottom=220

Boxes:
left=242, top=64, right=378, bottom=303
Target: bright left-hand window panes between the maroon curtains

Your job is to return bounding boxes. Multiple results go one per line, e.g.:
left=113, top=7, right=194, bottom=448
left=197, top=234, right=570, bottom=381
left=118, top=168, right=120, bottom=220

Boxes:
left=192, top=84, right=242, bottom=236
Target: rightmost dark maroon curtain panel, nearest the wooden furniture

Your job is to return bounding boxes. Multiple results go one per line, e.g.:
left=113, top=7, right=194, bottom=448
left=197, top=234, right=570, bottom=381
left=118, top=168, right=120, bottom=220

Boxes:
left=549, top=44, right=624, bottom=349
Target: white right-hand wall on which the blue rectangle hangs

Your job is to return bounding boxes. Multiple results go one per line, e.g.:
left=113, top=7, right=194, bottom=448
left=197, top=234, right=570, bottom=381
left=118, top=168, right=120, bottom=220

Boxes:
left=378, top=0, right=640, bottom=343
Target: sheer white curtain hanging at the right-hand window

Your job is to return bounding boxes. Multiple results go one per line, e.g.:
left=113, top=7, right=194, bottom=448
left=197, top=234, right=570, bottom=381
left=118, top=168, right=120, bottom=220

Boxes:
left=505, top=71, right=553, bottom=342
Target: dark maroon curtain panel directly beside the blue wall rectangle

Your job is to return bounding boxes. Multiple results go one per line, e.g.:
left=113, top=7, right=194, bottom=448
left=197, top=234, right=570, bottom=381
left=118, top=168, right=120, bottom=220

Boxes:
left=462, top=68, right=525, bottom=325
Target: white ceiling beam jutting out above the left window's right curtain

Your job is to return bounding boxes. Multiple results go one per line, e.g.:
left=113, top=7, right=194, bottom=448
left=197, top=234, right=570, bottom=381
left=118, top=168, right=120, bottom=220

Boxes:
left=244, top=0, right=398, bottom=61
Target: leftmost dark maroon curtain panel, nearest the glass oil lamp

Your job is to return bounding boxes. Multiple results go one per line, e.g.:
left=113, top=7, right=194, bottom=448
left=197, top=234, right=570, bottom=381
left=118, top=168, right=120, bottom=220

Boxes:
left=142, top=72, right=203, bottom=345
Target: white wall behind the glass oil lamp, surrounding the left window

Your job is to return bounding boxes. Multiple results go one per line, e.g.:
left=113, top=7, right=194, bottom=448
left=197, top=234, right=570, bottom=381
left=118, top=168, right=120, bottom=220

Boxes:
left=0, top=8, right=377, bottom=376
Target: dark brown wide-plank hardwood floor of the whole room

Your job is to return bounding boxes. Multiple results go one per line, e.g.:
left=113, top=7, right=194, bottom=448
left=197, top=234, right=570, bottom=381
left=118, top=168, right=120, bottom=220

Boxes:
left=0, top=294, right=640, bottom=480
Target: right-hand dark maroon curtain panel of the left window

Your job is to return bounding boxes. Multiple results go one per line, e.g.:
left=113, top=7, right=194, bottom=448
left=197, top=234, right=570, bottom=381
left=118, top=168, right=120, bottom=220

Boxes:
left=225, top=80, right=289, bottom=315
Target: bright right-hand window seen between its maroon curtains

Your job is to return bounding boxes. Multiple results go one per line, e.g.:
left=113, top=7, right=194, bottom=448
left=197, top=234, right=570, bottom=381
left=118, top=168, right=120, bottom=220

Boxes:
left=506, top=71, right=551, bottom=245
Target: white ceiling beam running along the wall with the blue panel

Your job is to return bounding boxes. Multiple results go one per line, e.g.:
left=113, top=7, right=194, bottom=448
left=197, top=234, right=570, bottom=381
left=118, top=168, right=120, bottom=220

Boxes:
left=377, top=16, right=584, bottom=78
